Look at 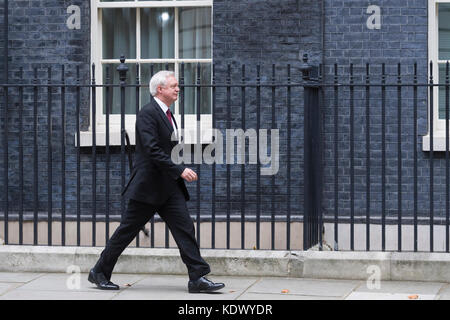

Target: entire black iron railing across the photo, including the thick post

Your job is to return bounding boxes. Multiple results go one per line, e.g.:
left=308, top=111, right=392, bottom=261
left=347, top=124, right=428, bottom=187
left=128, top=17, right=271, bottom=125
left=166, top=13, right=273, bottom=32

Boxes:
left=0, top=58, right=450, bottom=252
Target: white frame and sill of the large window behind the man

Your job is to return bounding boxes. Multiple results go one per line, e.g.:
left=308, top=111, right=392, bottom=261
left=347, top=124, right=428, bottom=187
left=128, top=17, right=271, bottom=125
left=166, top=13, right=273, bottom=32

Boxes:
left=76, top=0, right=213, bottom=147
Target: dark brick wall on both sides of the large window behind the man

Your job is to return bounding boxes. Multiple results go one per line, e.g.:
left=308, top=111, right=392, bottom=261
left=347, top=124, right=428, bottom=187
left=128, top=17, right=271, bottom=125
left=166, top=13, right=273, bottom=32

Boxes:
left=0, top=1, right=321, bottom=225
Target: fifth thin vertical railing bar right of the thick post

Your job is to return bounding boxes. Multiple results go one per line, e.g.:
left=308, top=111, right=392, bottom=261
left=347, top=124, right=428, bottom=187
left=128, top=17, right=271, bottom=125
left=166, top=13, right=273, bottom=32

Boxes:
left=397, top=63, right=402, bottom=252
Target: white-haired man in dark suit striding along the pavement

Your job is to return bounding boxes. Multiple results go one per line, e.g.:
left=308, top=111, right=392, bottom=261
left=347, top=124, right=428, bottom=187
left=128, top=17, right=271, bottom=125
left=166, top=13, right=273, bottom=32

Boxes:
left=88, top=71, right=225, bottom=293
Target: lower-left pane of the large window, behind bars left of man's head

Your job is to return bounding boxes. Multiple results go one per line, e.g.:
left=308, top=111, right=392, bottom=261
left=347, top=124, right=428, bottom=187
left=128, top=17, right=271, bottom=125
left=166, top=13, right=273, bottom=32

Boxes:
left=103, top=63, right=136, bottom=114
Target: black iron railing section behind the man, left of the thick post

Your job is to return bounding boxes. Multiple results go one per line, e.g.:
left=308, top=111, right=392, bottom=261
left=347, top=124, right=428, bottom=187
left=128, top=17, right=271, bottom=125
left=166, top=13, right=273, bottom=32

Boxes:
left=0, top=58, right=310, bottom=249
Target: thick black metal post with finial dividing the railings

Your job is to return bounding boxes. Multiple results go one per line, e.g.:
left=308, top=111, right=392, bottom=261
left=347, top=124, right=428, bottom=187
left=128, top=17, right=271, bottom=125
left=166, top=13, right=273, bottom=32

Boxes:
left=300, top=54, right=323, bottom=250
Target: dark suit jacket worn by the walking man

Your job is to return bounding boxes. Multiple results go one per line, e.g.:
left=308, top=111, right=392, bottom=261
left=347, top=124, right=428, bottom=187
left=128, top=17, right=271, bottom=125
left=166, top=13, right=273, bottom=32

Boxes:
left=122, top=97, right=189, bottom=206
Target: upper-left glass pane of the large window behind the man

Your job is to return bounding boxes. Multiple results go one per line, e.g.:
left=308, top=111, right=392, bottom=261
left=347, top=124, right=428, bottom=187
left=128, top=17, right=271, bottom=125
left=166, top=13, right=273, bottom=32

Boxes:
left=102, top=8, right=136, bottom=59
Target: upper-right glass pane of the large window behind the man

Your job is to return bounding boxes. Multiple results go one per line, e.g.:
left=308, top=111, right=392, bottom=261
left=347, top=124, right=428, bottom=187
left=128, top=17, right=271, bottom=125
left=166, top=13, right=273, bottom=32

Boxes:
left=179, top=8, right=211, bottom=59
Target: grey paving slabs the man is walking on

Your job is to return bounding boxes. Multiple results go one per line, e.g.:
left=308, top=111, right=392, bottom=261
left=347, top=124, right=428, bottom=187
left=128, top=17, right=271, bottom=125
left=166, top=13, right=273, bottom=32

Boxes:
left=0, top=272, right=450, bottom=302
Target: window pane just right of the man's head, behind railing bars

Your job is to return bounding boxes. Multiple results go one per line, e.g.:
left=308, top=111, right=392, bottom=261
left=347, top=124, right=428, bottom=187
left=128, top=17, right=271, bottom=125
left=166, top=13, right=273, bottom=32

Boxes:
left=179, top=63, right=212, bottom=114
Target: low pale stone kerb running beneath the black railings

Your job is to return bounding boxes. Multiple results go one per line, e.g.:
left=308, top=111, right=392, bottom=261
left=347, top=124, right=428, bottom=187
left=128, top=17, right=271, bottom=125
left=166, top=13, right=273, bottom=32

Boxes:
left=4, top=245, right=450, bottom=283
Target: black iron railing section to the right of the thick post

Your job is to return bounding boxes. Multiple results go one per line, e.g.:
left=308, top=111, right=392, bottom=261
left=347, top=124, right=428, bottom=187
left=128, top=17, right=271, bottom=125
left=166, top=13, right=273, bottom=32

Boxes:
left=319, top=62, right=450, bottom=252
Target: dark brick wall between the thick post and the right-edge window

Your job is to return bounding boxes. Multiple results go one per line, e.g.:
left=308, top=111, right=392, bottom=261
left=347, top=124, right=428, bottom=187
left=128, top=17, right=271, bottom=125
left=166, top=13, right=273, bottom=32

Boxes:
left=324, top=0, right=430, bottom=222
